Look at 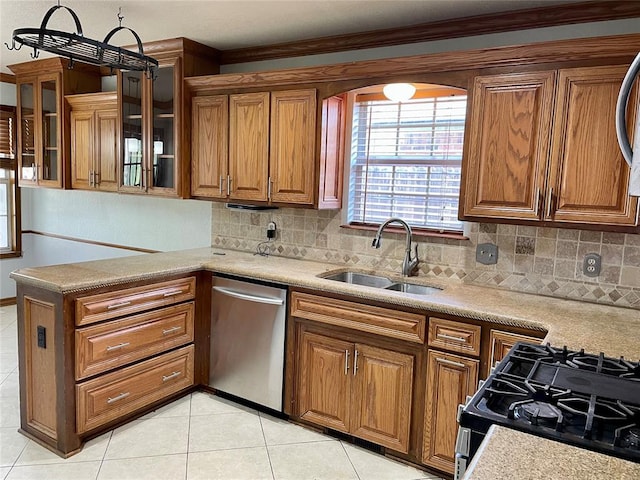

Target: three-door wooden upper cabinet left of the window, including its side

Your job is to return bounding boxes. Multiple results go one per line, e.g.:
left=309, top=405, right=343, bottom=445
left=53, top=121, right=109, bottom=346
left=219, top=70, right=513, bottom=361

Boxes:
left=191, top=88, right=345, bottom=208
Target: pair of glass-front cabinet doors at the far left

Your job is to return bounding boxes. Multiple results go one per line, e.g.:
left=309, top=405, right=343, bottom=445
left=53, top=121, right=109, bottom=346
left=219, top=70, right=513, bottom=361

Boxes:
left=17, top=74, right=63, bottom=188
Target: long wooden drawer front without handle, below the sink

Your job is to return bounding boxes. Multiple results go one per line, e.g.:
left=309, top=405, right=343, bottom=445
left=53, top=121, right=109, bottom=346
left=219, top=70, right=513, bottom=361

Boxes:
left=291, top=292, right=426, bottom=343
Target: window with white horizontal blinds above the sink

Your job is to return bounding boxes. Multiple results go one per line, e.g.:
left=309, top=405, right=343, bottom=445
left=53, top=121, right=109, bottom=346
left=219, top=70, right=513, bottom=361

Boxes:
left=347, top=87, right=467, bottom=232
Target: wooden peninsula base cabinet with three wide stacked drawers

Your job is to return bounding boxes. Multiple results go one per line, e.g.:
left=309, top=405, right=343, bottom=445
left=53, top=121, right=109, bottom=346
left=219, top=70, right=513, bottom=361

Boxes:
left=16, top=275, right=200, bottom=458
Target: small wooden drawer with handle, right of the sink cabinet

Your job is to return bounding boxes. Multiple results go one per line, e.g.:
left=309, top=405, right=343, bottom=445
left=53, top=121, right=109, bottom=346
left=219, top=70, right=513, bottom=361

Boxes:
left=429, top=317, right=481, bottom=356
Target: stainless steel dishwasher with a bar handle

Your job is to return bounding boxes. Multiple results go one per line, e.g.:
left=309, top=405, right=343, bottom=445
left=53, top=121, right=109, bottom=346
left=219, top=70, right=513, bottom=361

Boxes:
left=209, top=277, right=287, bottom=412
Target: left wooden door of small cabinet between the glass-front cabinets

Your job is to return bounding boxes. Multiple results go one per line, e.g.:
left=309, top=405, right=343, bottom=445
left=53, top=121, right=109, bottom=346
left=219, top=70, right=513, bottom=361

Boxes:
left=71, top=111, right=95, bottom=189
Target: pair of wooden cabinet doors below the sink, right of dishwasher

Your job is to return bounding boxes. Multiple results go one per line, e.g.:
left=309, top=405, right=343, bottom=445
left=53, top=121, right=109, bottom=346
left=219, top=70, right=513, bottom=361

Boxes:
left=297, top=326, right=414, bottom=453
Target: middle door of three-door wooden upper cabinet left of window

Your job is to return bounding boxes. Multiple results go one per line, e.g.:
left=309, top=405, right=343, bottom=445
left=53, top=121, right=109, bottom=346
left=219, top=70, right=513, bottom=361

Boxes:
left=227, top=92, right=269, bottom=201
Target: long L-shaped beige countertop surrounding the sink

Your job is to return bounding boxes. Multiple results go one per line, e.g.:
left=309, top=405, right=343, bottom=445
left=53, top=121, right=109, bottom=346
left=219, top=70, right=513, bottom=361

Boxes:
left=11, top=248, right=640, bottom=360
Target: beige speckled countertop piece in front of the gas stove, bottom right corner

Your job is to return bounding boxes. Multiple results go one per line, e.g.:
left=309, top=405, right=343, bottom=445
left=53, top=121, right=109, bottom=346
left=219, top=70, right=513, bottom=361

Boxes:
left=463, top=425, right=640, bottom=480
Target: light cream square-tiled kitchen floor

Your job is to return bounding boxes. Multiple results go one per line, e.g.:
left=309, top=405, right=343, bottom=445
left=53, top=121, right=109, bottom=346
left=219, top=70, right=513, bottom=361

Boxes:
left=0, top=306, right=438, bottom=480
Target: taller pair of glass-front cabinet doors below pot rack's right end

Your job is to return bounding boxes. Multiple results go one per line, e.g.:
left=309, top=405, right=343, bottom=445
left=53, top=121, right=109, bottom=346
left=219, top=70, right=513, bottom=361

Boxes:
left=120, top=59, right=181, bottom=196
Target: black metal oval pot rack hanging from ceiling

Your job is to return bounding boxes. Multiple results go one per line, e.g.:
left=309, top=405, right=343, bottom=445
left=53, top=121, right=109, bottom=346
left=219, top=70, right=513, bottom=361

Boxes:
left=5, top=2, right=158, bottom=78
